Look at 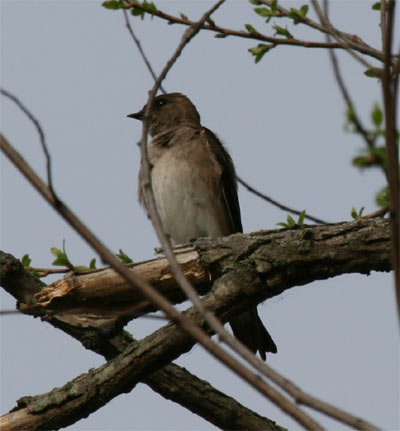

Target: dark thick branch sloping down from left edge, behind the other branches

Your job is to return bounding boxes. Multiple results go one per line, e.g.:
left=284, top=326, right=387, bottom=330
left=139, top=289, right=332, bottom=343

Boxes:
left=0, top=252, right=283, bottom=431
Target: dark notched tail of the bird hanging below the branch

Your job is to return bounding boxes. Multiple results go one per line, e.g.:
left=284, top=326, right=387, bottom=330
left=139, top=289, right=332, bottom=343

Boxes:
left=229, top=307, right=278, bottom=361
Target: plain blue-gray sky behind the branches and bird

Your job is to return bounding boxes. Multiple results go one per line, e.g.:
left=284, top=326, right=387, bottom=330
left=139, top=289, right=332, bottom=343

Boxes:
left=0, top=0, right=399, bottom=431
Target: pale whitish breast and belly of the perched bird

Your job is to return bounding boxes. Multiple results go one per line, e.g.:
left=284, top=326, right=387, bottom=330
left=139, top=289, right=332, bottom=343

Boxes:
left=152, top=143, right=231, bottom=244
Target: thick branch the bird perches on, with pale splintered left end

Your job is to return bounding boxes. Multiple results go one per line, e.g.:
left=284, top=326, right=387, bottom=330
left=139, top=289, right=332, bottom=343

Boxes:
left=15, top=219, right=391, bottom=319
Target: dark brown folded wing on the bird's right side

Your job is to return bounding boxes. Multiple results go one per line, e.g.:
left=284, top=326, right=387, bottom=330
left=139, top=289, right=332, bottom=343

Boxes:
left=204, top=127, right=243, bottom=233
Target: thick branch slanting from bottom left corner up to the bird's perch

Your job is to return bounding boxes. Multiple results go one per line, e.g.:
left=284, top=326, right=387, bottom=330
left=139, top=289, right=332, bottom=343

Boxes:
left=4, top=260, right=306, bottom=429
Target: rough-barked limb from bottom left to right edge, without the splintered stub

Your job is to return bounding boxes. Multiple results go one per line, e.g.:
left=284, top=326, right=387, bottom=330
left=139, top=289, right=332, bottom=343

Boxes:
left=0, top=220, right=391, bottom=429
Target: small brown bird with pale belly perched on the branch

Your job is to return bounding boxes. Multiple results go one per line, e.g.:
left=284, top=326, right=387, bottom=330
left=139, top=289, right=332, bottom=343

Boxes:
left=128, top=93, right=277, bottom=361
